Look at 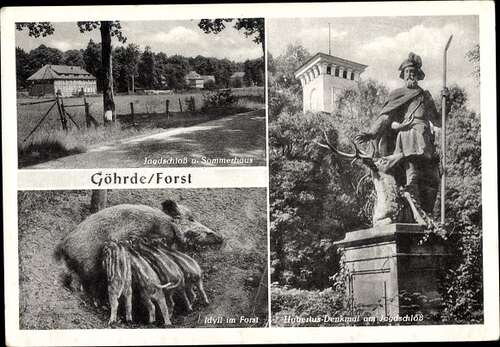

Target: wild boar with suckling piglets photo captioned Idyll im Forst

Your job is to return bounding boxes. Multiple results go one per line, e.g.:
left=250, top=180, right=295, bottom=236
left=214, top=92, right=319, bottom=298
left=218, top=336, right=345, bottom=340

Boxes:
left=18, top=188, right=268, bottom=330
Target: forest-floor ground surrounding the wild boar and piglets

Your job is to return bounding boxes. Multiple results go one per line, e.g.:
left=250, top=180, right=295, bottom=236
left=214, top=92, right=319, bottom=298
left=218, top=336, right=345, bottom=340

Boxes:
left=18, top=188, right=267, bottom=329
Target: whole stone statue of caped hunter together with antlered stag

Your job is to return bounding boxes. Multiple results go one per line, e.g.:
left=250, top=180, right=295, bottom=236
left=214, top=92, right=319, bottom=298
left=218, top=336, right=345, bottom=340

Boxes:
left=319, top=53, right=445, bottom=226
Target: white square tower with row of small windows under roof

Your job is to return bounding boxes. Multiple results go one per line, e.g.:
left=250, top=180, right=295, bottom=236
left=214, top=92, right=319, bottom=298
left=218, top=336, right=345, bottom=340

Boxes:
left=295, top=53, right=367, bottom=113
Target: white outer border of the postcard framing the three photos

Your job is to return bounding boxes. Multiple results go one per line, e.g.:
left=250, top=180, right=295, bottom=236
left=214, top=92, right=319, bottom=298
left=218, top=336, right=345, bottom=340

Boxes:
left=1, top=1, right=499, bottom=345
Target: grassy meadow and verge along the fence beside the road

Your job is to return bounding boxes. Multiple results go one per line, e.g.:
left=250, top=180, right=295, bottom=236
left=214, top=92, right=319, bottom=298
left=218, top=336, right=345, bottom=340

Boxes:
left=17, top=87, right=264, bottom=167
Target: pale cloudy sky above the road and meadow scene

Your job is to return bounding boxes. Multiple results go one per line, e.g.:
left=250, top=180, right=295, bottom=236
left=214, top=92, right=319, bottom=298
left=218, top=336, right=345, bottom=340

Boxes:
left=16, top=20, right=262, bottom=62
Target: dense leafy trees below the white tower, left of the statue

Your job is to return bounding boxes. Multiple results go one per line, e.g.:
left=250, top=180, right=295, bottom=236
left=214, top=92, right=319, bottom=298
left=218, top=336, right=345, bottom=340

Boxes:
left=269, top=81, right=387, bottom=288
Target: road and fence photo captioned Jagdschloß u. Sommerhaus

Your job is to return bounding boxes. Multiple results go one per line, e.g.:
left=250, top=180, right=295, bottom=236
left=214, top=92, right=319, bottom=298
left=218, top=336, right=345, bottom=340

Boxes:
left=16, top=18, right=266, bottom=169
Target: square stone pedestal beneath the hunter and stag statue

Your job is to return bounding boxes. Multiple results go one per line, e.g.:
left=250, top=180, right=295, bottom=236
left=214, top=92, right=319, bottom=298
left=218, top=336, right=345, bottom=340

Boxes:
left=336, top=224, right=448, bottom=317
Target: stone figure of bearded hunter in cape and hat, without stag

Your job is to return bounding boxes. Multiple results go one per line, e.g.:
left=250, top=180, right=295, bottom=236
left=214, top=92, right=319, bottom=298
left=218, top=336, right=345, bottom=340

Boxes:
left=356, top=53, right=441, bottom=213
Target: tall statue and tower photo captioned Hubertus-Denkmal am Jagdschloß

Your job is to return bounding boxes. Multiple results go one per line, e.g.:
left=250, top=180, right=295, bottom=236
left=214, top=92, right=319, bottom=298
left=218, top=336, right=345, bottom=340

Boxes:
left=267, top=16, right=484, bottom=326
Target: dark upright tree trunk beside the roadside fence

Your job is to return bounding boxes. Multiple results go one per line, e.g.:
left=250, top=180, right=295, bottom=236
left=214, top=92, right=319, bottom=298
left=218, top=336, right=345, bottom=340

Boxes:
left=101, top=21, right=116, bottom=123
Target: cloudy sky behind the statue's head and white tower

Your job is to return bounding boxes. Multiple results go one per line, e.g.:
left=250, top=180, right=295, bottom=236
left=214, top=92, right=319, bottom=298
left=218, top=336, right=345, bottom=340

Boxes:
left=266, top=16, right=480, bottom=111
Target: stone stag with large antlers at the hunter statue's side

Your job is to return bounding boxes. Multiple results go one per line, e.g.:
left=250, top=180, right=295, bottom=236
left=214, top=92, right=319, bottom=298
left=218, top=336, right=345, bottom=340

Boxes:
left=315, top=131, right=431, bottom=227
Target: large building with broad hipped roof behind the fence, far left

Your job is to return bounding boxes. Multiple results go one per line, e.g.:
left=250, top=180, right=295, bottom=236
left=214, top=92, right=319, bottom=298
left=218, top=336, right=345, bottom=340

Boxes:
left=28, top=65, right=97, bottom=97
